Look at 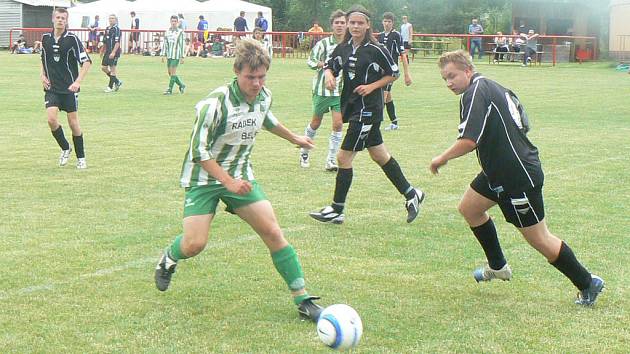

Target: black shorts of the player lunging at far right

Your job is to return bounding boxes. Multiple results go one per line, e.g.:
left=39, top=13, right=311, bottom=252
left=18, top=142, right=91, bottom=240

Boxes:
left=470, top=173, right=545, bottom=228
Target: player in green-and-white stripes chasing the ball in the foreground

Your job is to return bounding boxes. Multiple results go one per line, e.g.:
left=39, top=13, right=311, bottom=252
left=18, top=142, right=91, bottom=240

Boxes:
left=155, top=39, right=322, bottom=321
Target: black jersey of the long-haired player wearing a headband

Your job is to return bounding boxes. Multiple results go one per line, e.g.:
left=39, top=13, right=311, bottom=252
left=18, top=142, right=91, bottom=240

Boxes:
left=324, top=39, right=399, bottom=124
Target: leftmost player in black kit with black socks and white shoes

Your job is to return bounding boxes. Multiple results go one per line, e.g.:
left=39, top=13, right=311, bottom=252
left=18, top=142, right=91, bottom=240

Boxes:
left=41, top=7, right=92, bottom=169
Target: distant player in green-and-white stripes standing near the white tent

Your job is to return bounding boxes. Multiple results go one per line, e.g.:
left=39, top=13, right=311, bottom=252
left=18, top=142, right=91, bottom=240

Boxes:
left=162, top=15, right=186, bottom=95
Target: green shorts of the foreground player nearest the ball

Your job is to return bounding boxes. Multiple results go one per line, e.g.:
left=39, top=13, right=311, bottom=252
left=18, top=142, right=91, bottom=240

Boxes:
left=184, top=181, right=267, bottom=217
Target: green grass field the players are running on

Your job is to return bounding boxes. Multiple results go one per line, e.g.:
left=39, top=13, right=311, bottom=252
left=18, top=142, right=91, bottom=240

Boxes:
left=0, top=53, right=630, bottom=353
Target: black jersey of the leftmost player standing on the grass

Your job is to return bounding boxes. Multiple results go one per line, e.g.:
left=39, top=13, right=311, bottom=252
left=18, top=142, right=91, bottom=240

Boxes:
left=41, top=31, right=92, bottom=94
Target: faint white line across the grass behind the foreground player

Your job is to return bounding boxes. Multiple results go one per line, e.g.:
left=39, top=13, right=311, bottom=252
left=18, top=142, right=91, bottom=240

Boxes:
left=0, top=225, right=309, bottom=301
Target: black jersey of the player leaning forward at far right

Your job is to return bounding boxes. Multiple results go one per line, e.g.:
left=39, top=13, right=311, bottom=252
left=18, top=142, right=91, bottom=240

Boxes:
left=459, top=74, right=544, bottom=192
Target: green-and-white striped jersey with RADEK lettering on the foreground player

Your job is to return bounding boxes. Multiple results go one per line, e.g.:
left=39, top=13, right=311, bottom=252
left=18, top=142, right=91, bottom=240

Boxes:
left=180, top=79, right=278, bottom=187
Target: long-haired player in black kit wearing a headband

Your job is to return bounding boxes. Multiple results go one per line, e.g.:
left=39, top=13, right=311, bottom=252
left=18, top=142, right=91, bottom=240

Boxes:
left=310, top=6, right=424, bottom=224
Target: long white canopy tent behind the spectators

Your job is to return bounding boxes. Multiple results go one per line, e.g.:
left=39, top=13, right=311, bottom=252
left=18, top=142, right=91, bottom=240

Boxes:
left=68, top=0, right=272, bottom=31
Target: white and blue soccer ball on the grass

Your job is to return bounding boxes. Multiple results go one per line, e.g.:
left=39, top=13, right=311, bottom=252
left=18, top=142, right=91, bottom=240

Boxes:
left=317, top=304, right=363, bottom=350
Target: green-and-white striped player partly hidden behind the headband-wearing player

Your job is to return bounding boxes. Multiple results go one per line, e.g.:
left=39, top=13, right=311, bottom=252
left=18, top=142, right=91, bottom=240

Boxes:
left=300, top=10, right=346, bottom=171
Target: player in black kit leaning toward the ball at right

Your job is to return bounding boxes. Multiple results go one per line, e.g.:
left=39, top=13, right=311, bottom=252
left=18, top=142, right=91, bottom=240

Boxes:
left=429, top=50, right=604, bottom=306
